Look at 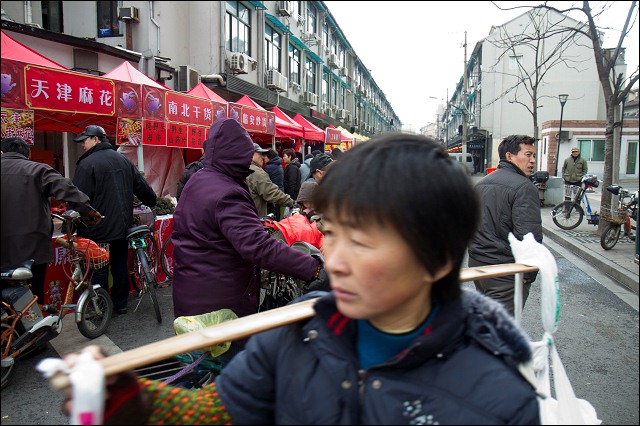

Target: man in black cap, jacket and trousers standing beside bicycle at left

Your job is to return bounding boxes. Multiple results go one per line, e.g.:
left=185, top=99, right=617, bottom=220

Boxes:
left=73, top=125, right=156, bottom=314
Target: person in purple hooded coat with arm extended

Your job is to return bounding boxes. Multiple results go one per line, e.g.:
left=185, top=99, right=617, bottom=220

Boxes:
left=171, top=118, right=326, bottom=362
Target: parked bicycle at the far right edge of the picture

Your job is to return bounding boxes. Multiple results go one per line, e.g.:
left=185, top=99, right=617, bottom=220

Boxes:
left=600, top=184, right=638, bottom=250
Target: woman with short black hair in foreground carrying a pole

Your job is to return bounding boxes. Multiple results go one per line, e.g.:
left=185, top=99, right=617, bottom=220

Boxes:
left=60, top=134, right=540, bottom=425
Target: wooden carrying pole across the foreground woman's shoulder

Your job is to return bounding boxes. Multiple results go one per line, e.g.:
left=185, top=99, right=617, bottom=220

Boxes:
left=51, top=263, right=538, bottom=389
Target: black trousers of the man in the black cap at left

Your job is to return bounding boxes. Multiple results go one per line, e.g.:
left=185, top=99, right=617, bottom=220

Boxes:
left=91, top=238, right=131, bottom=309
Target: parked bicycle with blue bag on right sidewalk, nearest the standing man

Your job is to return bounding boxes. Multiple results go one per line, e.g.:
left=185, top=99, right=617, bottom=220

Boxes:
left=551, top=175, right=600, bottom=231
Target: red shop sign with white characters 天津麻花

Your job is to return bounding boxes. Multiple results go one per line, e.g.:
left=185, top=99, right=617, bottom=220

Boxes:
left=24, top=65, right=115, bottom=116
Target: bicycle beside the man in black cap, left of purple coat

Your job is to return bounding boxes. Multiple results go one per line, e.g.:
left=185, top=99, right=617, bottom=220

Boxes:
left=126, top=206, right=162, bottom=324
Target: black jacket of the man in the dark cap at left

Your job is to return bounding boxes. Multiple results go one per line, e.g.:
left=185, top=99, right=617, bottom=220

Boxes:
left=73, top=141, right=156, bottom=243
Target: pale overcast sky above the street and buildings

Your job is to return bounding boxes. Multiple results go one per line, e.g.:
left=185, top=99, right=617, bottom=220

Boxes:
left=325, top=1, right=639, bottom=132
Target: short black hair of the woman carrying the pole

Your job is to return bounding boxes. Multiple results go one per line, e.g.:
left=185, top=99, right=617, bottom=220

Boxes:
left=313, top=133, right=479, bottom=301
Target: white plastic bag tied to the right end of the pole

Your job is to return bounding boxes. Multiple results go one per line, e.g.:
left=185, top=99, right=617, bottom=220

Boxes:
left=509, top=233, right=602, bottom=425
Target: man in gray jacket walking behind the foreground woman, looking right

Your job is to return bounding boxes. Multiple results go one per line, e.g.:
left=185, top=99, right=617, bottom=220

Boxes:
left=469, top=135, right=542, bottom=315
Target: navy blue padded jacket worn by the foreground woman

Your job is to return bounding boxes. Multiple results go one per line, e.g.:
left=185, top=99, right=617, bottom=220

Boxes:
left=216, top=290, right=540, bottom=425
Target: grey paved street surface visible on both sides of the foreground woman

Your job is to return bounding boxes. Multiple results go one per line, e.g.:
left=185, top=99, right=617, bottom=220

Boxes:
left=1, top=177, right=640, bottom=425
